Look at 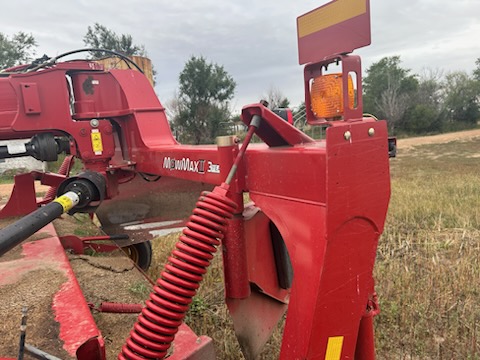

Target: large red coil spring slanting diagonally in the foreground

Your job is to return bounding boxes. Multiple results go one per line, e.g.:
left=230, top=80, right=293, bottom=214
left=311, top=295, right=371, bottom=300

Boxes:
left=118, top=187, right=236, bottom=360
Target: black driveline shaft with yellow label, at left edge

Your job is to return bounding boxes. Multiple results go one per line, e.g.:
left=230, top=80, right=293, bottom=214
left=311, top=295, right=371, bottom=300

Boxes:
left=0, top=191, right=80, bottom=256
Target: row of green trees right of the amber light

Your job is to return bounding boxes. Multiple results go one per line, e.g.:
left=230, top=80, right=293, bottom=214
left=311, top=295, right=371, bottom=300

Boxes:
left=363, top=56, right=480, bottom=134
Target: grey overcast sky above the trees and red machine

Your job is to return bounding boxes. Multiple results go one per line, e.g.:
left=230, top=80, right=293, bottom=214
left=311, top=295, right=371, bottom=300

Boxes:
left=0, top=0, right=480, bottom=109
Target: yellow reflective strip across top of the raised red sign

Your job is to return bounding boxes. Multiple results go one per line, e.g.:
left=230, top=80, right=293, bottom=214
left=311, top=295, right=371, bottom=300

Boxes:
left=298, top=0, right=367, bottom=38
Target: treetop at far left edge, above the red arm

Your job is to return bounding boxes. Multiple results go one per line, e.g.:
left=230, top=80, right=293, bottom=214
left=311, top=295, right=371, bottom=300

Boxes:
left=0, top=31, right=37, bottom=69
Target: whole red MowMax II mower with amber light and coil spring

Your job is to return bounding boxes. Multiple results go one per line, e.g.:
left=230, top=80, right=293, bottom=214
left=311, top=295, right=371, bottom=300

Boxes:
left=0, top=0, right=391, bottom=360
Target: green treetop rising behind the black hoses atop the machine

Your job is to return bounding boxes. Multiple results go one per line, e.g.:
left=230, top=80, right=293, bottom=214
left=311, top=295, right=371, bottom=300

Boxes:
left=83, top=23, right=146, bottom=59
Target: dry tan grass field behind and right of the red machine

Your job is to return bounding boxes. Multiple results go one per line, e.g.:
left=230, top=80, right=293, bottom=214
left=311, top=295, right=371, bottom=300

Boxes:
left=143, top=131, right=480, bottom=359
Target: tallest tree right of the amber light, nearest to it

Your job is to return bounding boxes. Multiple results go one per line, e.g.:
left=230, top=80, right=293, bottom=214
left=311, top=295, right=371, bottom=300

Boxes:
left=363, top=56, right=418, bottom=131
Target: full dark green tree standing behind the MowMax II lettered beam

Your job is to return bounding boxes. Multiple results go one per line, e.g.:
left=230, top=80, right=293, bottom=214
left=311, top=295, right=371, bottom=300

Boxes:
left=172, top=56, right=236, bottom=144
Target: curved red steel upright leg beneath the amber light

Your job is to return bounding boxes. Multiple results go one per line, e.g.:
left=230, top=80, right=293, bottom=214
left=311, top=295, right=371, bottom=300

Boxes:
left=247, top=120, right=390, bottom=359
